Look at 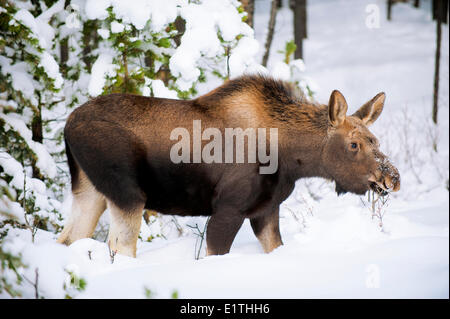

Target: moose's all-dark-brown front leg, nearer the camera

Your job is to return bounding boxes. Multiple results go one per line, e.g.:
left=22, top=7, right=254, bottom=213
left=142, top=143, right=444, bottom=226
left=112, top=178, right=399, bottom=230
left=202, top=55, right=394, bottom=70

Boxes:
left=206, top=207, right=244, bottom=256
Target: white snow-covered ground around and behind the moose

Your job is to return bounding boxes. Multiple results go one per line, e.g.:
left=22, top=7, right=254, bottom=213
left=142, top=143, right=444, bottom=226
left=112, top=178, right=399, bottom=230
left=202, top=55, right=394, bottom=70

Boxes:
left=0, top=0, right=449, bottom=298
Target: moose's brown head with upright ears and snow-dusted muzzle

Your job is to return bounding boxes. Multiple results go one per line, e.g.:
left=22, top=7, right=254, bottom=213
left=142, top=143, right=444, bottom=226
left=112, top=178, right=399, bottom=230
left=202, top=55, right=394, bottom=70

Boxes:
left=322, top=90, right=400, bottom=195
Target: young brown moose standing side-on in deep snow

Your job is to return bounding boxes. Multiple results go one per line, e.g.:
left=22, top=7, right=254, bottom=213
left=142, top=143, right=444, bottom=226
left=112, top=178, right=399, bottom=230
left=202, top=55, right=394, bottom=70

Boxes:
left=59, top=76, right=400, bottom=255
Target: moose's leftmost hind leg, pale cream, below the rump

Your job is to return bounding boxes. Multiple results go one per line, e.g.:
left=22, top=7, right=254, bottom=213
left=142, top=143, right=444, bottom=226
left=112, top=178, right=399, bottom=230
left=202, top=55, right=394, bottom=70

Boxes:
left=57, top=170, right=106, bottom=245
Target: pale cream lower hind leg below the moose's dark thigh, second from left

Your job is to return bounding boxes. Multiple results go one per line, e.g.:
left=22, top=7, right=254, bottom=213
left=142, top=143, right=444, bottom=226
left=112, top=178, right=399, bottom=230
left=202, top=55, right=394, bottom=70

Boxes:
left=106, top=200, right=144, bottom=257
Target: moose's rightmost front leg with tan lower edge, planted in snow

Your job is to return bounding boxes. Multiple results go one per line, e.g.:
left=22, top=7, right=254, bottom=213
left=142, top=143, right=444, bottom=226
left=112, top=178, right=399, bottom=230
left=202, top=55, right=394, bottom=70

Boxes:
left=250, top=207, right=283, bottom=253
